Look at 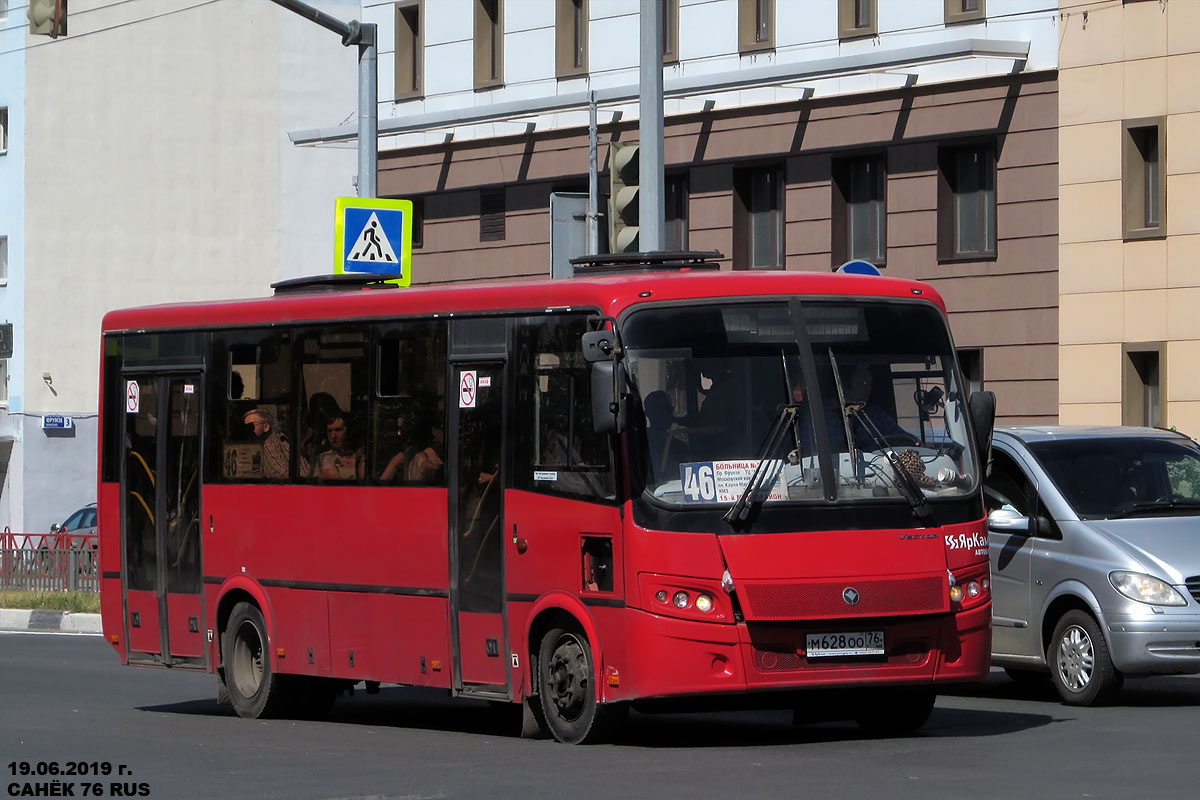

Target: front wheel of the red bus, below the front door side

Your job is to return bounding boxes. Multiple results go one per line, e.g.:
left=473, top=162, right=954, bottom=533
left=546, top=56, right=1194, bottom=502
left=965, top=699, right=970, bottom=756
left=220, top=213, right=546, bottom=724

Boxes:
left=538, top=627, right=625, bottom=745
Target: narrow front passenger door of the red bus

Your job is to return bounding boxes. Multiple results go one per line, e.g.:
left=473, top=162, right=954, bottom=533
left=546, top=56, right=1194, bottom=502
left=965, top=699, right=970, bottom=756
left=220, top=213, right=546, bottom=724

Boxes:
left=448, top=361, right=510, bottom=698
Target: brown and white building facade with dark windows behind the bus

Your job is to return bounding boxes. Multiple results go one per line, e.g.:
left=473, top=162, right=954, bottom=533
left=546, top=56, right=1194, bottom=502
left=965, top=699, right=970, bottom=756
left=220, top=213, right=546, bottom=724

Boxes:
left=312, top=0, right=1060, bottom=423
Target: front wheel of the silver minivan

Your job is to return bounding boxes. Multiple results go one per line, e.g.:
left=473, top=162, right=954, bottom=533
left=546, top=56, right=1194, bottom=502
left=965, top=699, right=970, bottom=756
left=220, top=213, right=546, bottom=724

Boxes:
left=1046, top=609, right=1123, bottom=705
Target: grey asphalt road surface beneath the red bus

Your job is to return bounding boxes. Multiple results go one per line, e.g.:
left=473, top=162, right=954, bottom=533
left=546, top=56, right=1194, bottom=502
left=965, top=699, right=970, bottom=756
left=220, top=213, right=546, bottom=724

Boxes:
left=0, top=634, right=1200, bottom=800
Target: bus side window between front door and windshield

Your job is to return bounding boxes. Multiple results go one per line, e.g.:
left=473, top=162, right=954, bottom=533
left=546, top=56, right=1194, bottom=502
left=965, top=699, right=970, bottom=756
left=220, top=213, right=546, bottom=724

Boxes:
left=509, top=314, right=616, bottom=499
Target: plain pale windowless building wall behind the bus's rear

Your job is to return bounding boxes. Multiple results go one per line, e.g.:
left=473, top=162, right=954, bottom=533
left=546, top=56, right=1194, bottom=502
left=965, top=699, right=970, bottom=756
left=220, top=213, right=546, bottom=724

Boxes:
left=0, top=0, right=359, bottom=533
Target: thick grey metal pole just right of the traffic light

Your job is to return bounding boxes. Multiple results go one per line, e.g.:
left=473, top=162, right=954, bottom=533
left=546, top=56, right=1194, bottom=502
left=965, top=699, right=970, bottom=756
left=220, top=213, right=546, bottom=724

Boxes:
left=637, top=0, right=666, bottom=252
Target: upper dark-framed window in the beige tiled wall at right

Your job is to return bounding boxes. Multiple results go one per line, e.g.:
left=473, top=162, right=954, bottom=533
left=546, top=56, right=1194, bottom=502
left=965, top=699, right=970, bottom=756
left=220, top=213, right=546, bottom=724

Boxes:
left=1121, top=118, right=1166, bottom=239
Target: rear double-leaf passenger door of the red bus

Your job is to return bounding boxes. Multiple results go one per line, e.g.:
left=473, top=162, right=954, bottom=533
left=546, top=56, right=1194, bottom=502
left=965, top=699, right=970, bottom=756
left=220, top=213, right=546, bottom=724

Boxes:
left=121, top=373, right=206, bottom=664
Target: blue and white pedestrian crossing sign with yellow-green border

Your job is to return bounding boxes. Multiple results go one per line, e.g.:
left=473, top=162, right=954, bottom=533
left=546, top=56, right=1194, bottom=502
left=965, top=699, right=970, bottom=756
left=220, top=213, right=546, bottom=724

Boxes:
left=334, top=197, right=413, bottom=287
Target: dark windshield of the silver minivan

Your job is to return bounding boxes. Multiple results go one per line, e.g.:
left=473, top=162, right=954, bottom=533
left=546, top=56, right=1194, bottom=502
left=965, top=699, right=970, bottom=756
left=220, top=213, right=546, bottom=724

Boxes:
left=1028, top=437, right=1200, bottom=519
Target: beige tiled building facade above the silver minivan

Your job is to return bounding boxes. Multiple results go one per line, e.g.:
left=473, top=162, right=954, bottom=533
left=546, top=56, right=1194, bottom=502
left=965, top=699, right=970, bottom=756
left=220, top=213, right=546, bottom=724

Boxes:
left=1058, top=0, right=1200, bottom=437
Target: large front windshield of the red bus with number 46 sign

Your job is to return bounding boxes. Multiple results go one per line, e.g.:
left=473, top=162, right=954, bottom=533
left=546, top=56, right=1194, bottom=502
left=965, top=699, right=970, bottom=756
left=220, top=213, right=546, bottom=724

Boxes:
left=622, top=301, right=978, bottom=505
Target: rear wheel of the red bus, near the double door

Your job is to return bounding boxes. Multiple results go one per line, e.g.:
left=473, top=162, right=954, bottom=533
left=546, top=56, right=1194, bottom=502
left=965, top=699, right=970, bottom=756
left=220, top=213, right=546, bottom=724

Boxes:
left=221, top=602, right=286, bottom=720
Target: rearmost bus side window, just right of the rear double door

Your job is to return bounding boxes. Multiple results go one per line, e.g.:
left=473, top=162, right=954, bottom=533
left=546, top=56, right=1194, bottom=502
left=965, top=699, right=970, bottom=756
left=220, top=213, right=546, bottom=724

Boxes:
left=212, top=331, right=292, bottom=483
